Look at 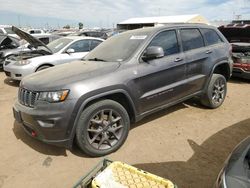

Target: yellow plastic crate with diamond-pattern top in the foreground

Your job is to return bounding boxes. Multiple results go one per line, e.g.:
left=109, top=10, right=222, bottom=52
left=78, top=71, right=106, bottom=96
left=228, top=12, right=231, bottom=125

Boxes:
left=92, top=161, right=175, bottom=188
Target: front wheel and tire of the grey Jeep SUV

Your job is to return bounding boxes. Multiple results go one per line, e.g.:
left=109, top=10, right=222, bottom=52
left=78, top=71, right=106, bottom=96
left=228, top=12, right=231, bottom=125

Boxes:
left=76, top=100, right=130, bottom=157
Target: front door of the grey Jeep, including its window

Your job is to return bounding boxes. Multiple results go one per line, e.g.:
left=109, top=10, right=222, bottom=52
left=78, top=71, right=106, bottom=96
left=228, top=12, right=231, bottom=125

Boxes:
left=135, top=30, right=186, bottom=113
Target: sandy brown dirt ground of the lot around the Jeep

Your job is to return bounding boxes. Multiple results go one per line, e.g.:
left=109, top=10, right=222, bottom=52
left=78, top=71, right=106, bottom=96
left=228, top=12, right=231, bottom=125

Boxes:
left=0, top=72, right=250, bottom=188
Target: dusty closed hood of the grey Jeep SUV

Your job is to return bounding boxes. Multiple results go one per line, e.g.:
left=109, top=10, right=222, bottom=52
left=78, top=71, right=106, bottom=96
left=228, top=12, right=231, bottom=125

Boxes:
left=20, top=61, right=120, bottom=91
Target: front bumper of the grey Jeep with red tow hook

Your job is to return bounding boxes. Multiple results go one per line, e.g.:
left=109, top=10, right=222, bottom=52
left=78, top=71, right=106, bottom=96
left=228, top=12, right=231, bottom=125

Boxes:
left=13, top=100, right=76, bottom=148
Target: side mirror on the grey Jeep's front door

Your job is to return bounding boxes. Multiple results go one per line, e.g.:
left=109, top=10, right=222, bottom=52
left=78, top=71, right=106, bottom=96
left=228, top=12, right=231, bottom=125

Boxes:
left=142, top=46, right=164, bottom=61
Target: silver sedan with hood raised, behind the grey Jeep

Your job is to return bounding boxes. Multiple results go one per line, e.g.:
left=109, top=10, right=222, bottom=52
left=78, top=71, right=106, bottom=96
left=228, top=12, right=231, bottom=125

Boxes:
left=4, top=25, right=103, bottom=80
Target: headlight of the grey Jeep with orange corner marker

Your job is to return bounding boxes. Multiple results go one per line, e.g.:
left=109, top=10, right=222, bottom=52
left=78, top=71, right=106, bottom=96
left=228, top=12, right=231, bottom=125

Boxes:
left=38, top=90, right=69, bottom=102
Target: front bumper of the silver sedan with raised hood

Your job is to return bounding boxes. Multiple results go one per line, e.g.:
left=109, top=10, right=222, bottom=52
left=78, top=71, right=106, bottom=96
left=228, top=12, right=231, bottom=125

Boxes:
left=3, top=64, right=35, bottom=80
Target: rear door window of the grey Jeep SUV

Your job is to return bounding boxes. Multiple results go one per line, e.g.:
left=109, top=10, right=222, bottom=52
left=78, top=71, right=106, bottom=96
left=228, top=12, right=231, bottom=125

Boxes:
left=180, top=29, right=204, bottom=51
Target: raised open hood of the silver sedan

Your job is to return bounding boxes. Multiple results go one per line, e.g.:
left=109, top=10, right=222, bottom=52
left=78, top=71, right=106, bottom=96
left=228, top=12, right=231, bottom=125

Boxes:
left=12, top=26, right=52, bottom=54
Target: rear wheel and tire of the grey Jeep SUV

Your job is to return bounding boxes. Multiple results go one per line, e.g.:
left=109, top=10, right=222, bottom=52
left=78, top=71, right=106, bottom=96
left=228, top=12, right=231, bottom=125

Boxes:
left=201, top=74, right=227, bottom=109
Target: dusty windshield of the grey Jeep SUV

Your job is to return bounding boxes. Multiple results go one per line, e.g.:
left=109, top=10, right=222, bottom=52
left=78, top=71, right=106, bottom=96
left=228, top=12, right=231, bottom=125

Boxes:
left=84, top=30, right=150, bottom=62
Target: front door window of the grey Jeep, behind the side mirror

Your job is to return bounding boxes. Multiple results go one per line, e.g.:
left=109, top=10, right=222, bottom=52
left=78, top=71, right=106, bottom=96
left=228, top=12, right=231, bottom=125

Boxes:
left=149, top=30, right=180, bottom=56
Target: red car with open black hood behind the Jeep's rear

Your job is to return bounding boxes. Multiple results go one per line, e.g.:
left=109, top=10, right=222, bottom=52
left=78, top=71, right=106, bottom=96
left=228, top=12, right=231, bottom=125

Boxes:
left=219, top=23, right=250, bottom=79
